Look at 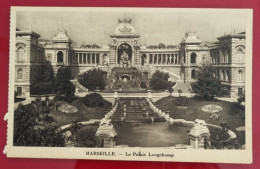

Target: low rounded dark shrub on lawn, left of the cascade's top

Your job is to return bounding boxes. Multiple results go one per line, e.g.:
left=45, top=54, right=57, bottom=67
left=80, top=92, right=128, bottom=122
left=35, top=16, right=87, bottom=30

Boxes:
left=84, top=93, right=104, bottom=108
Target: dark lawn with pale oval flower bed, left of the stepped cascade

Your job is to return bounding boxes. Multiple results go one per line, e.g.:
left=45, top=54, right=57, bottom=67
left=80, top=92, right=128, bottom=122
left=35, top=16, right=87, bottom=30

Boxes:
left=50, top=98, right=112, bottom=126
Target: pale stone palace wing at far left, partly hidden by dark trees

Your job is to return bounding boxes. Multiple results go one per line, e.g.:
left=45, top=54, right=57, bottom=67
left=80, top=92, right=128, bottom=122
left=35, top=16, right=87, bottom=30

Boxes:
left=15, top=30, right=45, bottom=97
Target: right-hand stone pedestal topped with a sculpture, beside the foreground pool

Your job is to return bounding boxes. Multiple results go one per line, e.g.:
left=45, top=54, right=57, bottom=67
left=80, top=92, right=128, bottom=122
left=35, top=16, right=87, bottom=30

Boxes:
left=189, top=119, right=210, bottom=149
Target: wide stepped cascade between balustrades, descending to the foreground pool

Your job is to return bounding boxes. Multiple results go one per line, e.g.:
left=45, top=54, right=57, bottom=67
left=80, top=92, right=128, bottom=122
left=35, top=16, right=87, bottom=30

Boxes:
left=111, top=97, right=165, bottom=123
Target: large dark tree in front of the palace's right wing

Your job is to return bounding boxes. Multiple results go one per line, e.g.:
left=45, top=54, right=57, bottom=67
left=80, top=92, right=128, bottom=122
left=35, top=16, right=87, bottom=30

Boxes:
left=194, top=65, right=226, bottom=100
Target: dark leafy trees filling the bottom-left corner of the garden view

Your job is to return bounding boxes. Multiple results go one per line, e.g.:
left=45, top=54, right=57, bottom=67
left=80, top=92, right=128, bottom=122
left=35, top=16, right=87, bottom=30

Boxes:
left=13, top=104, right=65, bottom=147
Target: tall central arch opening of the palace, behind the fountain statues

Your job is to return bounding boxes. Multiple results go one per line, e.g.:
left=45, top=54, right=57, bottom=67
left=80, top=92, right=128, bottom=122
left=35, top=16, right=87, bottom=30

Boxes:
left=117, top=43, right=132, bottom=64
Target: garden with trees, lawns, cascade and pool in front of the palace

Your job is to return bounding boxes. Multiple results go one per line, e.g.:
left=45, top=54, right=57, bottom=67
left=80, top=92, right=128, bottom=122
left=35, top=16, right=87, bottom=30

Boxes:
left=14, top=65, right=245, bottom=149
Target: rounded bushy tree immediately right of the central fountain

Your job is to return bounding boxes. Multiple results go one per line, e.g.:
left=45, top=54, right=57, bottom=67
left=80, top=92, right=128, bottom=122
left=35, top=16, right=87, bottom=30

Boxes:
left=150, top=70, right=174, bottom=90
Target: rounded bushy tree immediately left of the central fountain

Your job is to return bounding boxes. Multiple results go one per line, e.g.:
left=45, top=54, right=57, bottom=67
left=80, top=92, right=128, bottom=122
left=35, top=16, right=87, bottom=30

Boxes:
left=79, top=69, right=106, bottom=91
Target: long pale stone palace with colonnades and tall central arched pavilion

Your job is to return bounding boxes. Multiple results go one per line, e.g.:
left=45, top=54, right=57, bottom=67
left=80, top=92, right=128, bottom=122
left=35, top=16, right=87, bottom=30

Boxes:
left=15, top=18, right=246, bottom=98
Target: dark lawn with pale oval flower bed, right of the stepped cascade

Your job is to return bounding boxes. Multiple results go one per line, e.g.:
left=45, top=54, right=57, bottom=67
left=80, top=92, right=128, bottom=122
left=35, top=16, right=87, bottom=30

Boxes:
left=156, top=97, right=245, bottom=131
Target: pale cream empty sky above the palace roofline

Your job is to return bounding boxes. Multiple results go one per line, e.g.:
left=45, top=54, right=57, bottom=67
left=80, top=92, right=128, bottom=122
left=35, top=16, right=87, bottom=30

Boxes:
left=16, top=8, right=246, bottom=46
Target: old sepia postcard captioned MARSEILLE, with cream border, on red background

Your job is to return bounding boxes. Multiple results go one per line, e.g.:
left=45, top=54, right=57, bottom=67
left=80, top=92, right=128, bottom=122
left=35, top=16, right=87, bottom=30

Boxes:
left=6, top=7, right=252, bottom=163
